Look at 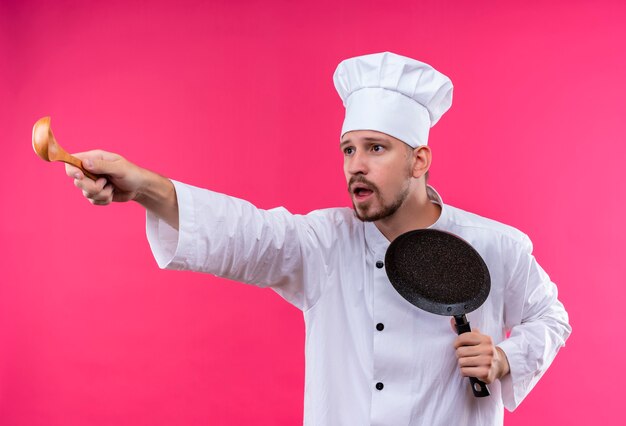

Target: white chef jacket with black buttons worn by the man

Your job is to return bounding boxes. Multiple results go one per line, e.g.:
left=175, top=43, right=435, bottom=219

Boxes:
left=147, top=182, right=571, bottom=426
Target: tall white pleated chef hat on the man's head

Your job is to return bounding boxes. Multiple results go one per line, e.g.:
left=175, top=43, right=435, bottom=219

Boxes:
left=333, top=52, right=452, bottom=148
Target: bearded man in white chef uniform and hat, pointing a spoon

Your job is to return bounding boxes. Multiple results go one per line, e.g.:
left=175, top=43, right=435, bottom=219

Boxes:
left=67, top=53, right=571, bottom=426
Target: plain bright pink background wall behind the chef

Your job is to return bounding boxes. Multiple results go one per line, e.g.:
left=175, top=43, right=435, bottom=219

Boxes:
left=0, top=0, right=626, bottom=426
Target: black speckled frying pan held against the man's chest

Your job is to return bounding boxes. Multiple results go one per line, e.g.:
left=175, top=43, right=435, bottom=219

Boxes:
left=385, top=229, right=491, bottom=397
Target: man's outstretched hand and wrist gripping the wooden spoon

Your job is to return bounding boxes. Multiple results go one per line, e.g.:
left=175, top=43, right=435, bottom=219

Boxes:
left=65, top=150, right=178, bottom=229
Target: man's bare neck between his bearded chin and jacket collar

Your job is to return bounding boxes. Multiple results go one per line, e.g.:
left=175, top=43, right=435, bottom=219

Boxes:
left=374, top=186, right=441, bottom=241
